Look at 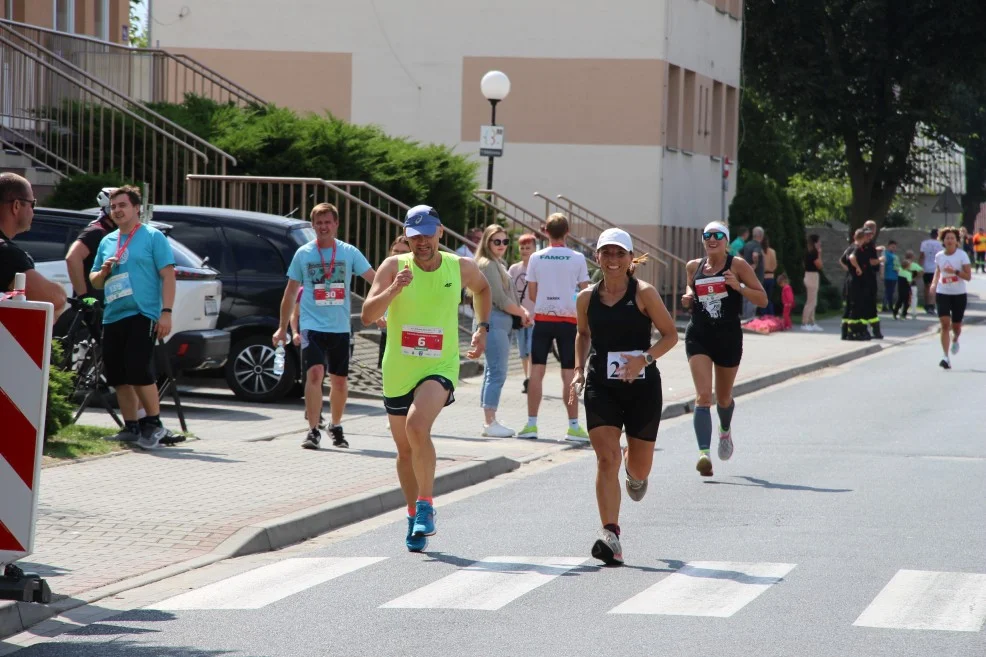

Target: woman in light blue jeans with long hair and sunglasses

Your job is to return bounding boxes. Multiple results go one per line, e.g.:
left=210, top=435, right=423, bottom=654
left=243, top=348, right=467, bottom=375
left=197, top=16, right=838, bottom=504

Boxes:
left=476, top=224, right=531, bottom=438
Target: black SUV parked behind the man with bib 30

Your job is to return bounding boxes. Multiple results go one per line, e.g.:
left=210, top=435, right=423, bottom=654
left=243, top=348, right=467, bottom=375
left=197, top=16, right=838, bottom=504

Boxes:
left=125, top=205, right=315, bottom=402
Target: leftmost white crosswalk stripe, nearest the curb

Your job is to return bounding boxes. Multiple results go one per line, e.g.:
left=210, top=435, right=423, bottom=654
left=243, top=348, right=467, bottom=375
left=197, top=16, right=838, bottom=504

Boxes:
left=149, top=557, right=386, bottom=611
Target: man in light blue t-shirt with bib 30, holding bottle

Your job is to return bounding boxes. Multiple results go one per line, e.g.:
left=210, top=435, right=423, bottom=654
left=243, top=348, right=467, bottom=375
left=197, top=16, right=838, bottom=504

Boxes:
left=274, top=203, right=376, bottom=449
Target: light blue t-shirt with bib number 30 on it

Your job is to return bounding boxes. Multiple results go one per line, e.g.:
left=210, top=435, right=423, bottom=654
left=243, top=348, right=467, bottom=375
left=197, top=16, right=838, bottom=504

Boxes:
left=288, top=239, right=370, bottom=333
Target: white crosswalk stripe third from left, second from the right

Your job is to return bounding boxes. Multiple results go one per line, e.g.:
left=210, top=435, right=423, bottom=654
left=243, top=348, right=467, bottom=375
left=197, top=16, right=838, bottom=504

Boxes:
left=609, top=561, right=796, bottom=618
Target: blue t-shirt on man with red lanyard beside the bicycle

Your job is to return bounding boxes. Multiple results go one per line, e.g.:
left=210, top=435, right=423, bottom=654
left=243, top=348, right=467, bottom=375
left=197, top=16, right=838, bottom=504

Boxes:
left=92, top=224, right=175, bottom=324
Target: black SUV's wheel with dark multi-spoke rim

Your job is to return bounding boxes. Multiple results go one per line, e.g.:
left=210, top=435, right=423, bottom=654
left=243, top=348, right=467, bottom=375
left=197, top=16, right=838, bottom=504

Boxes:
left=226, top=335, right=298, bottom=403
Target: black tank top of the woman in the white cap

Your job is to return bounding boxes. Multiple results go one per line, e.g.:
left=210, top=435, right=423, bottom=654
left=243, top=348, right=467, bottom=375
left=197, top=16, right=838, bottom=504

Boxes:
left=587, top=278, right=657, bottom=385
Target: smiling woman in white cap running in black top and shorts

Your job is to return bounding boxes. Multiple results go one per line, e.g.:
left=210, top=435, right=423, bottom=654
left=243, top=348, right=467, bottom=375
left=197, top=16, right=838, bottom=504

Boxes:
left=569, top=228, right=678, bottom=564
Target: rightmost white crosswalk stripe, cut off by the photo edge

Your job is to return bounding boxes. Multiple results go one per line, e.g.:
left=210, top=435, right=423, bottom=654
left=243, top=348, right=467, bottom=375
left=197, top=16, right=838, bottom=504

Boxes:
left=853, top=570, right=986, bottom=632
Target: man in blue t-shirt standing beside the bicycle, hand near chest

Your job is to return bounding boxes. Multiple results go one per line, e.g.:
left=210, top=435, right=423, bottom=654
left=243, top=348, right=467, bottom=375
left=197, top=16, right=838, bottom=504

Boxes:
left=89, top=186, right=175, bottom=449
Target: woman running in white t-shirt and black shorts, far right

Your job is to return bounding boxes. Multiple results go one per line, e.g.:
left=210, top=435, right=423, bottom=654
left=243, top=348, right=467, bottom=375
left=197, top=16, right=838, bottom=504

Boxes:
left=931, top=228, right=972, bottom=370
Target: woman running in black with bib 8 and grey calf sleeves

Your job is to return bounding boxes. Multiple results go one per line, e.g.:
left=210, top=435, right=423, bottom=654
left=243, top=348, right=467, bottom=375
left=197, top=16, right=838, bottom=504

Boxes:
left=681, top=221, right=767, bottom=477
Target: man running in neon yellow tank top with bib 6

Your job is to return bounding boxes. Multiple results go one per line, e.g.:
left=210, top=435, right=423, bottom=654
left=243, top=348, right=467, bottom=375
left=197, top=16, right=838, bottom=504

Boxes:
left=361, top=205, right=492, bottom=552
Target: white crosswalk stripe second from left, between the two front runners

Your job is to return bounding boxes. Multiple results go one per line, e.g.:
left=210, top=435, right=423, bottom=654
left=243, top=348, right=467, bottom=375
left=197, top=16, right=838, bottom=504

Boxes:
left=380, top=557, right=587, bottom=611
